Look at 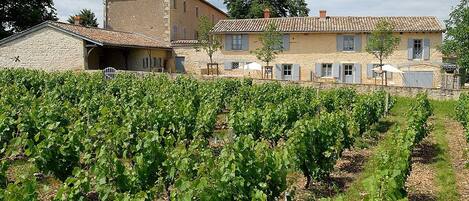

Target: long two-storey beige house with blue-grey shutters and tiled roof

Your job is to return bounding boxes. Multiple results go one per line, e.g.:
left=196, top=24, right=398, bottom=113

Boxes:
left=203, top=11, right=445, bottom=87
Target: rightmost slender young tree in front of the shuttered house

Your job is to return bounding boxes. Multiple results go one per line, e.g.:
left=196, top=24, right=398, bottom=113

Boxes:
left=366, top=20, right=401, bottom=85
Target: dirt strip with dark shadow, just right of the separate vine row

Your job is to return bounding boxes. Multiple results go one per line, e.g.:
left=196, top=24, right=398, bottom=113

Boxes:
left=406, top=135, right=438, bottom=201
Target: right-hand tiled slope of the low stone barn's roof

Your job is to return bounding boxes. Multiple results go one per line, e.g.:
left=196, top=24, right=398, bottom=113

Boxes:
left=48, top=22, right=170, bottom=48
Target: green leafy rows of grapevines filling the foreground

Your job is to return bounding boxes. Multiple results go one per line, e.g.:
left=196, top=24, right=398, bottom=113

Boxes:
left=0, top=70, right=454, bottom=200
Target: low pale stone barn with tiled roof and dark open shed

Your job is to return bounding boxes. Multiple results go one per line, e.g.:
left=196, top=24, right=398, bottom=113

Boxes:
left=0, top=22, right=174, bottom=71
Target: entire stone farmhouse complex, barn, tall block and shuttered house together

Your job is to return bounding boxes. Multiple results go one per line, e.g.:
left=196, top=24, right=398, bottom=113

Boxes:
left=0, top=0, right=445, bottom=88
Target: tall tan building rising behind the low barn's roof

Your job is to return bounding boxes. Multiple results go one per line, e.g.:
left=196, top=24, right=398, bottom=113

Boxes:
left=105, top=0, right=228, bottom=42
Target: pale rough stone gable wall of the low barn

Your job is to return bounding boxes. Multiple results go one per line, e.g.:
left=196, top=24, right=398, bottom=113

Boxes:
left=0, top=27, right=85, bottom=71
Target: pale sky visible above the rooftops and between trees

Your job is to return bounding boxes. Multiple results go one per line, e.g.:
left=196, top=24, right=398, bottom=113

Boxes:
left=54, top=0, right=459, bottom=26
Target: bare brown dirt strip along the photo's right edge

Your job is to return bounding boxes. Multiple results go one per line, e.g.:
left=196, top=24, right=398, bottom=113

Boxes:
left=445, top=119, right=469, bottom=201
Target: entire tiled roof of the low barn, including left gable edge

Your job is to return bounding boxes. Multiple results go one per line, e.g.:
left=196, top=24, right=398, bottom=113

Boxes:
left=0, top=21, right=170, bottom=48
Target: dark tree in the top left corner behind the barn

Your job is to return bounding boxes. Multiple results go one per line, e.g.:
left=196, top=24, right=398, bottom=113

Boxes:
left=0, top=0, right=58, bottom=39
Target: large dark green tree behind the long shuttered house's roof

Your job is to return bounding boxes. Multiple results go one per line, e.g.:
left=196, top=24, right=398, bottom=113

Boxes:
left=224, top=0, right=309, bottom=19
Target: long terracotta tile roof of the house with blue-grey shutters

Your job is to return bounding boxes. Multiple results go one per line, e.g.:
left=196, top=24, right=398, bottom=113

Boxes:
left=213, top=17, right=445, bottom=33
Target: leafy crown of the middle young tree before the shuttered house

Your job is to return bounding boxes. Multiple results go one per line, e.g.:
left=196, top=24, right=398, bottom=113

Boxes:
left=251, top=23, right=283, bottom=66
